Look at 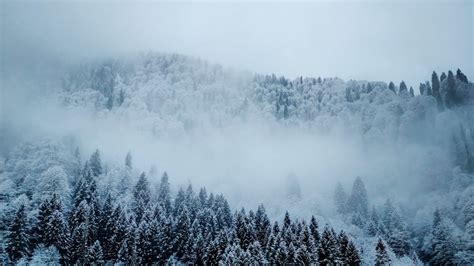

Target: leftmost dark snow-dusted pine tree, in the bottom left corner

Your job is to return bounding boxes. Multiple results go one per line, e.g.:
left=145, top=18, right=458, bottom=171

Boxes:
left=5, top=204, right=30, bottom=262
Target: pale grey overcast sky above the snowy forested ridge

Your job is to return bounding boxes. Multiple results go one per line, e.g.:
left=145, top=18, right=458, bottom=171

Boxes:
left=0, top=1, right=474, bottom=87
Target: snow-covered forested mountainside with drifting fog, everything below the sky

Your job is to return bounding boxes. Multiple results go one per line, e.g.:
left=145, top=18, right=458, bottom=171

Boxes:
left=0, top=53, right=474, bottom=265
